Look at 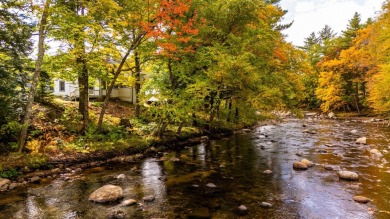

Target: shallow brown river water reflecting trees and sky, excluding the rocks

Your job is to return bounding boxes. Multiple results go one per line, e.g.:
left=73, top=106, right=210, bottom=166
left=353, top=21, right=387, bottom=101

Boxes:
left=0, top=119, right=390, bottom=219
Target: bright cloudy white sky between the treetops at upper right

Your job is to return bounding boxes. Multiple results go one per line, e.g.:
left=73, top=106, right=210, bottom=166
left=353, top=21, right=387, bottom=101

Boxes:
left=280, top=0, right=384, bottom=46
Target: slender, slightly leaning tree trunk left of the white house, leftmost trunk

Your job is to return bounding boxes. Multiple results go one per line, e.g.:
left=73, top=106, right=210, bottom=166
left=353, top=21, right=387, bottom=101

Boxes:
left=18, top=0, right=51, bottom=152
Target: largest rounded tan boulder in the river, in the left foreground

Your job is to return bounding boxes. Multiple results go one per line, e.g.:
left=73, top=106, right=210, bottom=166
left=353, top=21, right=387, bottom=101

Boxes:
left=88, top=185, right=123, bottom=203
